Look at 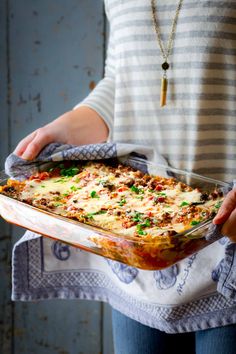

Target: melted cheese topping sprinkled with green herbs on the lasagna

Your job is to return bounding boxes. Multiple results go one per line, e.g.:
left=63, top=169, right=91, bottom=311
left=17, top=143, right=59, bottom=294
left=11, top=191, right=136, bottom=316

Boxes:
left=2, top=163, right=222, bottom=237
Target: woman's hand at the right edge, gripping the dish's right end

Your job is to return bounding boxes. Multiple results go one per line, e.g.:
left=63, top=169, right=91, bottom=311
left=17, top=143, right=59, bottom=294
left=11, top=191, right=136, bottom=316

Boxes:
left=213, top=189, right=236, bottom=242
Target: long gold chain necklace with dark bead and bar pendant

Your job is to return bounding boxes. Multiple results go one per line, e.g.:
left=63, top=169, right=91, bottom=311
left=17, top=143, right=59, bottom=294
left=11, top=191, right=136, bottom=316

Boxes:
left=151, top=0, right=183, bottom=107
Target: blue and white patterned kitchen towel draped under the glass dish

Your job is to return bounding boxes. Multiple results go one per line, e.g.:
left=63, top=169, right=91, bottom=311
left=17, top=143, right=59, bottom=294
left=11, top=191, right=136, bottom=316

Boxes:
left=2, top=143, right=236, bottom=331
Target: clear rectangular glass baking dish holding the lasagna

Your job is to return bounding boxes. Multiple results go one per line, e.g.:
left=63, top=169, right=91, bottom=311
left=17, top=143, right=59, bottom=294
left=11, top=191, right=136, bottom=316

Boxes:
left=0, top=157, right=229, bottom=270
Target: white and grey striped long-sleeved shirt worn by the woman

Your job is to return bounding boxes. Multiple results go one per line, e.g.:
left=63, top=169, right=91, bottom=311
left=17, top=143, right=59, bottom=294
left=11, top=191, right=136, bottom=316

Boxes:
left=78, top=0, right=236, bottom=181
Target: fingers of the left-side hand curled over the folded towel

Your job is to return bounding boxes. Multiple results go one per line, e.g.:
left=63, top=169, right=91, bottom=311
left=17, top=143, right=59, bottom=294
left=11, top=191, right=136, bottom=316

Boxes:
left=14, top=127, right=53, bottom=160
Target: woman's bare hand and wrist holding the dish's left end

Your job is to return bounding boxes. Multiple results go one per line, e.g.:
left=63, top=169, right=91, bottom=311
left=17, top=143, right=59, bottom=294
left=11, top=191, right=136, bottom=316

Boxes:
left=14, top=106, right=108, bottom=160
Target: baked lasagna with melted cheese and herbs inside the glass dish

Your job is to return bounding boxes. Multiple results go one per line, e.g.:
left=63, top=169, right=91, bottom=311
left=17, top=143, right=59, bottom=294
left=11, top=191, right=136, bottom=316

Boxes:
left=0, top=161, right=223, bottom=266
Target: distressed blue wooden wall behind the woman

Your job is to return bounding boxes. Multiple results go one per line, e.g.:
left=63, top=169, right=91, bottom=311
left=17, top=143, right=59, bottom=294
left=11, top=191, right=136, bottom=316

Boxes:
left=0, top=0, right=113, bottom=354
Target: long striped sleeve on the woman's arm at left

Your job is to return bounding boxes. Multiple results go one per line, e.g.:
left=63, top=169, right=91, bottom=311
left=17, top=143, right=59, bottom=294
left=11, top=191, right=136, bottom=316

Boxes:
left=74, top=1, right=115, bottom=140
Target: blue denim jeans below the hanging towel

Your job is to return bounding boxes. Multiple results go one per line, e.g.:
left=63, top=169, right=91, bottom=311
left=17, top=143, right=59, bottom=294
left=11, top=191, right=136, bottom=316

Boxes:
left=112, top=309, right=236, bottom=354
